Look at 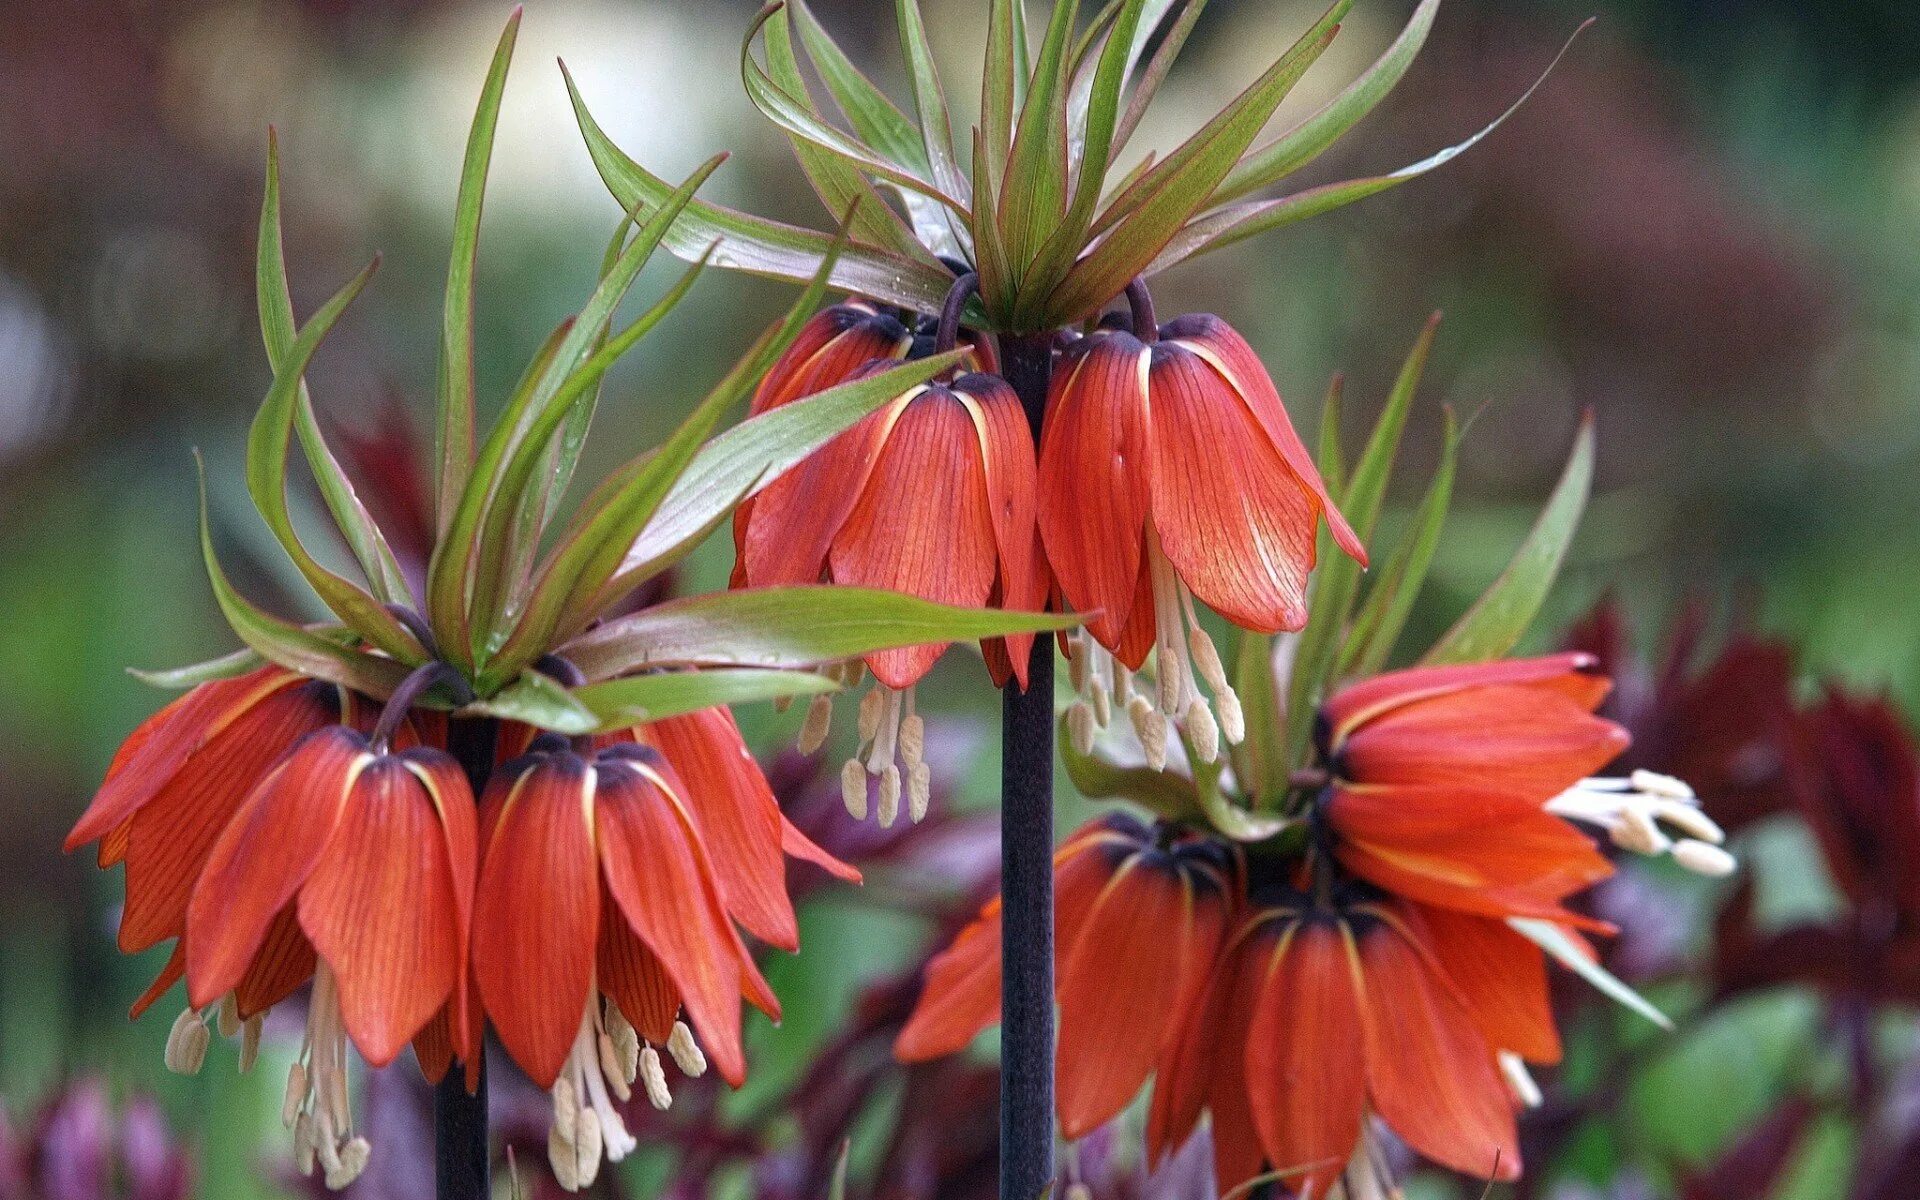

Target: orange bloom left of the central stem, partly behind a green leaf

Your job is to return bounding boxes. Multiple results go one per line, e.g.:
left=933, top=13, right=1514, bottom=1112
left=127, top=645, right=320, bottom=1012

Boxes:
left=735, top=362, right=1046, bottom=824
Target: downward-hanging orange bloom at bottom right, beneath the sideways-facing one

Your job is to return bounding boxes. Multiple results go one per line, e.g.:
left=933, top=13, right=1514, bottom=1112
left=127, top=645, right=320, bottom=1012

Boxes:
left=1148, top=889, right=1557, bottom=1200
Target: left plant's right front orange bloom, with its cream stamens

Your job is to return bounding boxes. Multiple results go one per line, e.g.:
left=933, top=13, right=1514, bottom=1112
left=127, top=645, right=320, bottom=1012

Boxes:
left=474, top=735, right=781, bottom=1187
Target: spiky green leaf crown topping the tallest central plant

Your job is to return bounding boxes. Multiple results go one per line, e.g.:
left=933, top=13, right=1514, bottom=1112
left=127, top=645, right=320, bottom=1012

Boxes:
left=574, top=0, right=1574, bottom=334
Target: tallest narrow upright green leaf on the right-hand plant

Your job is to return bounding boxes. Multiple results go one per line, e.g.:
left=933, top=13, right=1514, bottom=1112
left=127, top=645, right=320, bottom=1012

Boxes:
left=1286, top=313, right=1440, bottom=764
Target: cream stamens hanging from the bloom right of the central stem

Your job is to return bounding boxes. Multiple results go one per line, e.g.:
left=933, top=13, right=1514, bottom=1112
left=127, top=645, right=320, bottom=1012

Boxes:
left=1066, top=534, right=1246, bottom=770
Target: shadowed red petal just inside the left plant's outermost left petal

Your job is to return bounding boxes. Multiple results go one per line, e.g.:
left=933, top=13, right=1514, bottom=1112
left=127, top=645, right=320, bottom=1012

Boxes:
left=119, top=682, right=340, bottom=952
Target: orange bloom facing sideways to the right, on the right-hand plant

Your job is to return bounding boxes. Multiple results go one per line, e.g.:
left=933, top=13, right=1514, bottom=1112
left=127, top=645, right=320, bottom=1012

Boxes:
left=1319, top=655, right=1628, bottom=920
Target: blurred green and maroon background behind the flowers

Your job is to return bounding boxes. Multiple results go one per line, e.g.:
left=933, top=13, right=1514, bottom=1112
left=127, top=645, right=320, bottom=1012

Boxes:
left=0, top=0, right=1920, bottom=1200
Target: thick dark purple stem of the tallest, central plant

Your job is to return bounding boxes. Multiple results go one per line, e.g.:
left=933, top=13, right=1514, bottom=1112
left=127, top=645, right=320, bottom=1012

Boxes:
left=1000, top=336, right=1054, bottom=1200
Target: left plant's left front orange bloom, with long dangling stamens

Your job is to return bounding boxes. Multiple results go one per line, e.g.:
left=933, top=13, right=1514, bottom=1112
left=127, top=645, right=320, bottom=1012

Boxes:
left=175, top=726, right=476, bottom=1187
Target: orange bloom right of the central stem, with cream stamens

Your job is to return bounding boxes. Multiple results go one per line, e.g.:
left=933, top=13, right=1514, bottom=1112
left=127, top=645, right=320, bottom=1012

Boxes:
left=1039, top=315, right=1367, bottom=762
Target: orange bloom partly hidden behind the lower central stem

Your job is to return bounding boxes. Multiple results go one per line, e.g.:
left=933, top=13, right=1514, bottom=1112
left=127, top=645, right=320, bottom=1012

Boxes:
left=895, top=814, right=1235, bottom=1139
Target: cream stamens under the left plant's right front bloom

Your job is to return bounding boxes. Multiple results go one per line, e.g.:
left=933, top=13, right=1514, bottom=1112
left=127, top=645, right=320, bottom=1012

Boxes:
left=547, top=989, right=707, bottom=1192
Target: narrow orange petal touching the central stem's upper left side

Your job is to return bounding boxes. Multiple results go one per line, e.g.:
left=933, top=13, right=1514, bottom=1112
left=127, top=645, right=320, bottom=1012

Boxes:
left=954, top=374, right=1046, bottom=687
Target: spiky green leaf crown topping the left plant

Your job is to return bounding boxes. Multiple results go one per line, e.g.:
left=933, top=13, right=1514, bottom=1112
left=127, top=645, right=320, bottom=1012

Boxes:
left=157, top=13, right=1073, bottom=733
